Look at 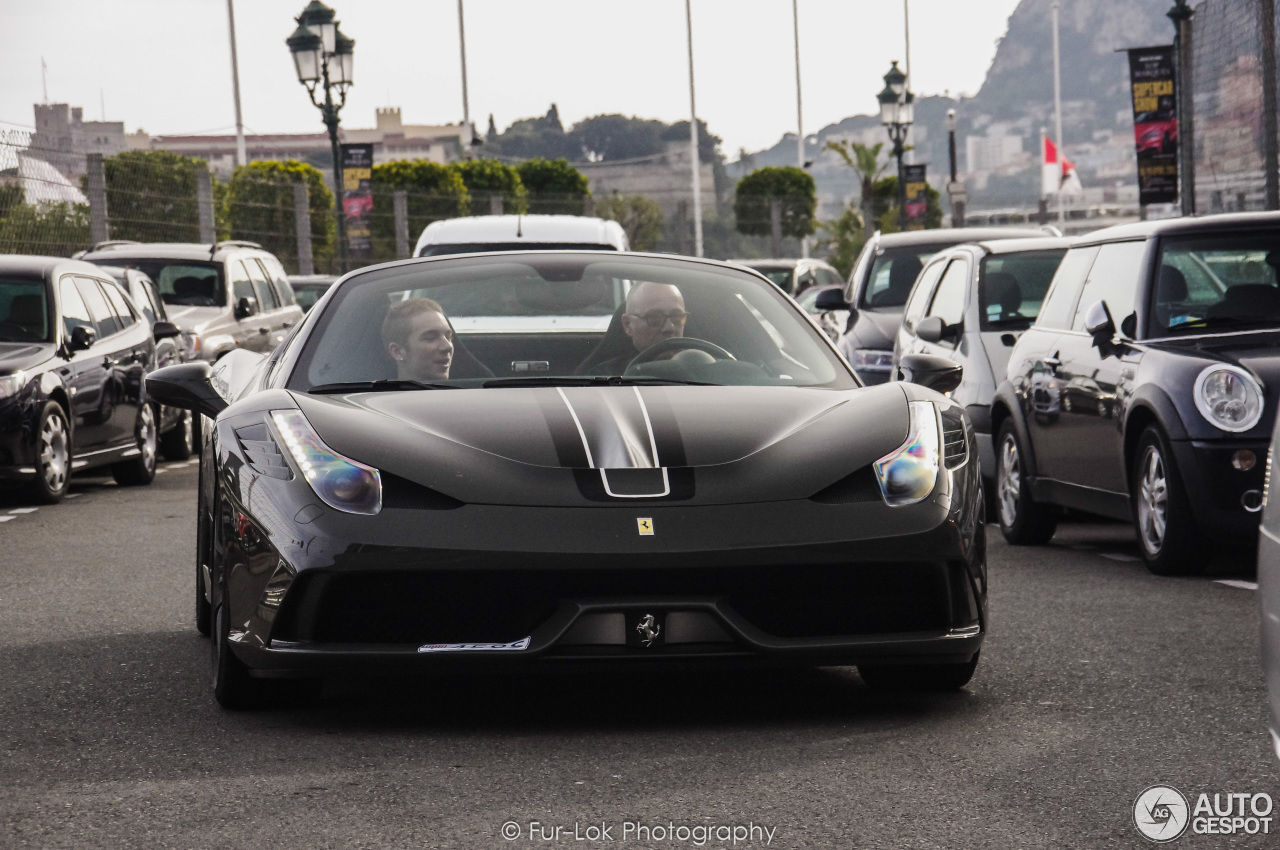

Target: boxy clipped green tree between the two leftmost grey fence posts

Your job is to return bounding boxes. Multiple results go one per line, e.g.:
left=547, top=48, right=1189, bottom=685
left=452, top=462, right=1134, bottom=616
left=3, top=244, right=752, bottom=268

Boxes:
left=102, top=151, right=209, bottom=242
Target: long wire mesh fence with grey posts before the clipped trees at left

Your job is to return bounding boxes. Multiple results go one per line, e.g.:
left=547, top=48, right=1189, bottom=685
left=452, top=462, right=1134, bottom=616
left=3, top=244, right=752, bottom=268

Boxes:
left=0, top=131, right=800, bottom=274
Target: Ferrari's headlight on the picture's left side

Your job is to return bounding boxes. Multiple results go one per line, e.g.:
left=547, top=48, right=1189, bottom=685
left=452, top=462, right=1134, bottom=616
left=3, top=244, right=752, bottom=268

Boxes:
left=271, top=410, right=383, bottom=515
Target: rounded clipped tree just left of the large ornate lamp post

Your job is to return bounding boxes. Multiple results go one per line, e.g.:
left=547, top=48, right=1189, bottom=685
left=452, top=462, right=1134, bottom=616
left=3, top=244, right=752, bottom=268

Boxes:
left=223, top=160, right=338, bottom=271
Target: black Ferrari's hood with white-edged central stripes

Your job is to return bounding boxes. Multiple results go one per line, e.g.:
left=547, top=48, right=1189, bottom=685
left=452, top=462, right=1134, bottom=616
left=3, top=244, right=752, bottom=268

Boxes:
left=294, top=384, right=909, bottom=504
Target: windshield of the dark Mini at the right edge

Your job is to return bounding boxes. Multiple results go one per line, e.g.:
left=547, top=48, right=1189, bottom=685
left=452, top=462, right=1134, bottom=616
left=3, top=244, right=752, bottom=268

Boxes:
left=1151, top=230, right=1280, bottom=334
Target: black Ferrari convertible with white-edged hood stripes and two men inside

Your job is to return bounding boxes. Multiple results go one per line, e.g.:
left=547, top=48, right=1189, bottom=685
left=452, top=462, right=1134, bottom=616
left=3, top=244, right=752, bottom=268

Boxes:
left=147, top=252, right=987, bottom=708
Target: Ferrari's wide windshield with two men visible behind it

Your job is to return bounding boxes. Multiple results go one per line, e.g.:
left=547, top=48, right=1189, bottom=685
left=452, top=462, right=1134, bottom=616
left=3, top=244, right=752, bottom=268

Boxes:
left=288, top=253, right=858, bottom=390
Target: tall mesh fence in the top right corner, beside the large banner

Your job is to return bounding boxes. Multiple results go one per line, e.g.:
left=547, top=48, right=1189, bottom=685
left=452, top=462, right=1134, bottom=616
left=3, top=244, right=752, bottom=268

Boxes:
left=1192, top=0, right=1280, bottom=213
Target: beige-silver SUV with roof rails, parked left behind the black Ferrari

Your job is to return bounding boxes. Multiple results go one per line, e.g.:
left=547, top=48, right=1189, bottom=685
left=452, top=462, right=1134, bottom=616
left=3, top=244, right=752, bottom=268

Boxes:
left=81, top=241, right=302, bottom=362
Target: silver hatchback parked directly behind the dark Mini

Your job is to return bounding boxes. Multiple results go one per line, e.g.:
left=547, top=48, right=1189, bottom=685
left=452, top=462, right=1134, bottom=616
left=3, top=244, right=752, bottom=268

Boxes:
left=893, top=237, right=1071, bottom=483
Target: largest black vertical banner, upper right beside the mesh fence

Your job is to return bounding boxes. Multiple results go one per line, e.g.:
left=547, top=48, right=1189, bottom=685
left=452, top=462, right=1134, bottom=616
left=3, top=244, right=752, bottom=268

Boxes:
left=1128, top=45, right=1178, bottom=205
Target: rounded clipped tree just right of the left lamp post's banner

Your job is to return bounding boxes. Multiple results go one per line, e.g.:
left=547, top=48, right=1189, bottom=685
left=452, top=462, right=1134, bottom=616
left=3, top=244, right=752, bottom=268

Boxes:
left=371, top=159, right=471, bottom=260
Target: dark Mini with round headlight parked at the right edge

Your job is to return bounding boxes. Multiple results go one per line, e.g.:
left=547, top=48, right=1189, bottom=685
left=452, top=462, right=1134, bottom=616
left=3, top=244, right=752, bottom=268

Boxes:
left=991, top=213, right=1280, bottom=575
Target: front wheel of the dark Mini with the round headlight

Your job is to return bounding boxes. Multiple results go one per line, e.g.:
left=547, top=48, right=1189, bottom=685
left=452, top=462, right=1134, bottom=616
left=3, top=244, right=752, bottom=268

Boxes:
left=1129, top=425, right=1208, bottom=576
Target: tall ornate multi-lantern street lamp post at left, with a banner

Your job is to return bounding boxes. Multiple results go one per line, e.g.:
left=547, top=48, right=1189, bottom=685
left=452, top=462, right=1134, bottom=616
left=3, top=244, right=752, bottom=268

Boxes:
left=284, top=0, right=356, bottom=273
